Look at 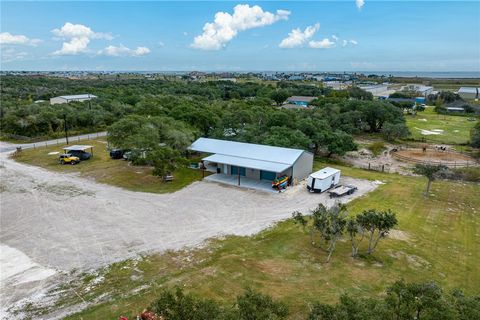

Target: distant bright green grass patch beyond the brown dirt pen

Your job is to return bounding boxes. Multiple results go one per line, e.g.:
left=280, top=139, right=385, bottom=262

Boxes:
left=405, top=107, right=476, bottom=144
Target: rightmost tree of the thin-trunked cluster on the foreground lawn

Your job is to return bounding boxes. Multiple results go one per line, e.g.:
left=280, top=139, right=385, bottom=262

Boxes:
left=356, top=209, right=398, bottom=254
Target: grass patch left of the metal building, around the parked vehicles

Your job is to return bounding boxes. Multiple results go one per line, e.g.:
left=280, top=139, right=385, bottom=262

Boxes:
left=15, top=139, right=202, bottom=193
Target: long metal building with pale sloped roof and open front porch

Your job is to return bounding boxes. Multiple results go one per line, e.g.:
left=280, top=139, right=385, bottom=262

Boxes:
left=189, top=138, right=313, bottom=183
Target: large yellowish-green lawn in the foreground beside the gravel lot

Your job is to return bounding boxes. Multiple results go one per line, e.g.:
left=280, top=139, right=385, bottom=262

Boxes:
left=59, top=162, right=480, bottom=319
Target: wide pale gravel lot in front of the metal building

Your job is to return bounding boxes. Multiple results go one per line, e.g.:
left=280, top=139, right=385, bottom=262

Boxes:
left=0, top=153, right=376, bottom=318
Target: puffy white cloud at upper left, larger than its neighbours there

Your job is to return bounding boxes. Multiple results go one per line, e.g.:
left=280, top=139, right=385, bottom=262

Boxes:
left=52, top=22, right=113, bottom=55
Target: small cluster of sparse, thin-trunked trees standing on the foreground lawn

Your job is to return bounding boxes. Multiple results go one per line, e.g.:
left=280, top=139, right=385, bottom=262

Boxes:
left=292, top=203, right=397, bottom=262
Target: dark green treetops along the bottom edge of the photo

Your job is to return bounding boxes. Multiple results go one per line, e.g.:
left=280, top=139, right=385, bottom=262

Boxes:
left=129, top=280, right=480, bottom=320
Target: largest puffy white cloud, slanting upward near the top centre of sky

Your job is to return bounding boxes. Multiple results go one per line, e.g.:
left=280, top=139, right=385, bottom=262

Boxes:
left=191, top=4, right=290, bottom=50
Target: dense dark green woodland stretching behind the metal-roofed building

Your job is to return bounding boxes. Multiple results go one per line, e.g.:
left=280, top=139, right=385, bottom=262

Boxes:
left=0, top=76, right=408, bottom=154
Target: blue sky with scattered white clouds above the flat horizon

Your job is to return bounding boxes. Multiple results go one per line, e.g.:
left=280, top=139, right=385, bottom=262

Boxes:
left=0, top=0, right=480, bottom=71
